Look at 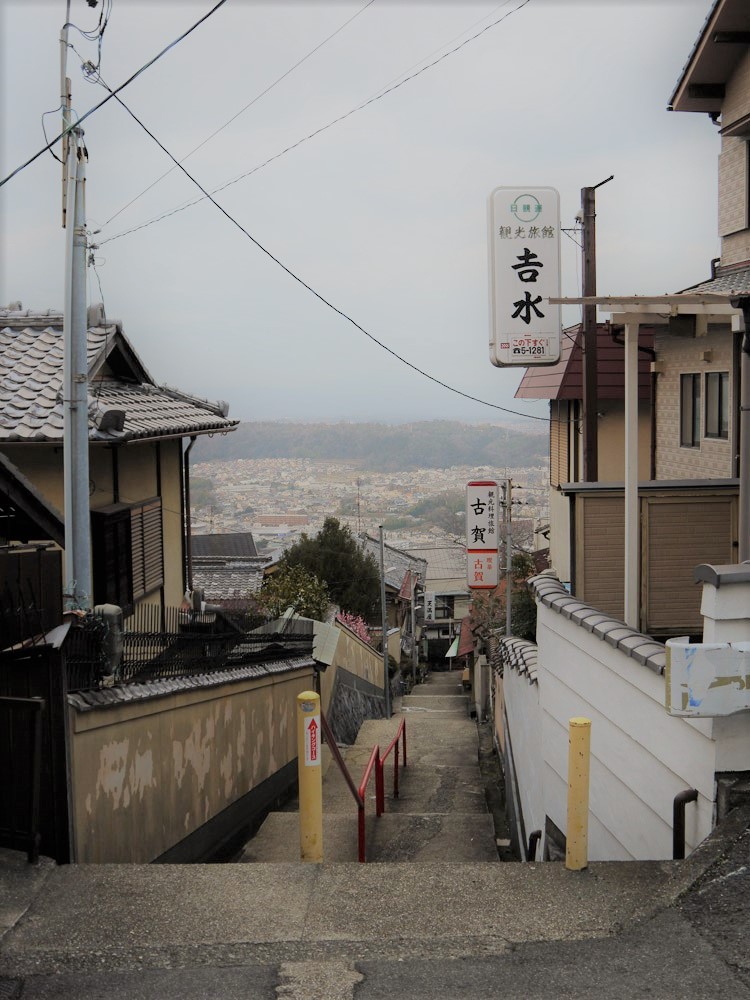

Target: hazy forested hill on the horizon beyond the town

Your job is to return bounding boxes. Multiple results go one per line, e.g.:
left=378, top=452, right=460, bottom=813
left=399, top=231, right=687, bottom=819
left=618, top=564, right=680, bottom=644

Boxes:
left=193, top=420, right=549, bottom=472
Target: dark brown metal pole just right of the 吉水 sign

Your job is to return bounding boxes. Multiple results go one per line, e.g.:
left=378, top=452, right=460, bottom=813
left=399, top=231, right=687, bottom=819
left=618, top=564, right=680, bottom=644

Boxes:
left=581, top=174, right=614, bottom=483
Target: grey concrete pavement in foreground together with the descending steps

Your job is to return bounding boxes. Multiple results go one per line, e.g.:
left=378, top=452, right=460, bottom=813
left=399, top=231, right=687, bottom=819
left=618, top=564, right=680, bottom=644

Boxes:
left=0, top=677, right=750, bottom=1000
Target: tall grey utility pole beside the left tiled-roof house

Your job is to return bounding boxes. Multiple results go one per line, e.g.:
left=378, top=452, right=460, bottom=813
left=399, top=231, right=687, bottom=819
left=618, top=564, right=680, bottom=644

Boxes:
left=60, top=9, right=92, bottom=611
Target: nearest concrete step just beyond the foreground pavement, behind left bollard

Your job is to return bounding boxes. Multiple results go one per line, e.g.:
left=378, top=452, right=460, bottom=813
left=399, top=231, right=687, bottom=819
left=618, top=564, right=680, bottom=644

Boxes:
left=239, top=804, right=498, bottom=864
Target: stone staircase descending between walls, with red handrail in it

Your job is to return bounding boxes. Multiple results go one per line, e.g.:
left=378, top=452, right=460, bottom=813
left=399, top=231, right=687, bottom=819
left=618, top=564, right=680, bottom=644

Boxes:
left=239, top=671, right=498, bottom=864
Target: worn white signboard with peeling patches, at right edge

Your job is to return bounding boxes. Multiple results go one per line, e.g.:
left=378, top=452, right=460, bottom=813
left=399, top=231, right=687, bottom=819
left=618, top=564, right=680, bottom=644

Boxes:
left=665, top=639, right=750, bottom=718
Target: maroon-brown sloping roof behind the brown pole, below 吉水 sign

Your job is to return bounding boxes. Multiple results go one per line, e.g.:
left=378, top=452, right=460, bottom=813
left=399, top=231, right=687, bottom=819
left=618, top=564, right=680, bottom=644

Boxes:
left=516, top=323, right=654, bottom=399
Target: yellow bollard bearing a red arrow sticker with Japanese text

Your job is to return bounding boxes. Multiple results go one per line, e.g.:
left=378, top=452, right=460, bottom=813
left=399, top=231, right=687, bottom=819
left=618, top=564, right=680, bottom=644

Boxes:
left=297, top=691, right=323, bottom=862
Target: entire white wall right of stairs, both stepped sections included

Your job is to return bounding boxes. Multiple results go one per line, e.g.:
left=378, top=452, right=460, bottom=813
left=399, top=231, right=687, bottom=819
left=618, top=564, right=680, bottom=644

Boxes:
left=496, top=578, right=750, bottom=860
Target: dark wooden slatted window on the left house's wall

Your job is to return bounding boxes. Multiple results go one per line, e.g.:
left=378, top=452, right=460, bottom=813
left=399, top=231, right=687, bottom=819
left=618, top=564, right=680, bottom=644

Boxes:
left=91, top=497, right=164, bottom=610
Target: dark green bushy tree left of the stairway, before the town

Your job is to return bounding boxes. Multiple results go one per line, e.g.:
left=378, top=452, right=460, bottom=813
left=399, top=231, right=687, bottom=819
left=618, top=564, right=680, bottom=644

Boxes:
left=281, top=517, right=380, bottom=621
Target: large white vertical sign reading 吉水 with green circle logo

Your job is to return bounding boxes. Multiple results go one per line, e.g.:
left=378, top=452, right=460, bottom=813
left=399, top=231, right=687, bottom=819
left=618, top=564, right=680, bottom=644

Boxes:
left=488, top=187, right=562, bottom=368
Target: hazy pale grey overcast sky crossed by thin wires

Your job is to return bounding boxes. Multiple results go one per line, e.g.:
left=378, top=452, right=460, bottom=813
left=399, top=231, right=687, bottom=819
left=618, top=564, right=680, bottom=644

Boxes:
left=0, top=0, right=719, bottom=428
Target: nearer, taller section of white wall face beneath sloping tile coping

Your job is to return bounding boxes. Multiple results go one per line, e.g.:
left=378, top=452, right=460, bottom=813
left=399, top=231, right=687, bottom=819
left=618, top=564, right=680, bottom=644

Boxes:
left=536, top=605, right=716, bottom=861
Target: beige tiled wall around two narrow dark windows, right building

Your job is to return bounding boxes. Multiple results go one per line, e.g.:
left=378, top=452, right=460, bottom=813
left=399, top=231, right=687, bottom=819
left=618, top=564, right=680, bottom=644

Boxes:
left=654, top=327, right=735, bottom=479
